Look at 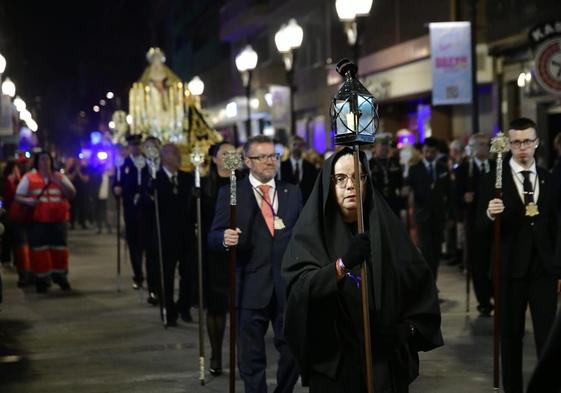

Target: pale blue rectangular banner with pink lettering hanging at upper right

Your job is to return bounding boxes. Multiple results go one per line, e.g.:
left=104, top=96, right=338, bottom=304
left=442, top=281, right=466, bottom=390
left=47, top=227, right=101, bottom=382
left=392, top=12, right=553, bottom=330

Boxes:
left=429, top=22, right=472, bottom=105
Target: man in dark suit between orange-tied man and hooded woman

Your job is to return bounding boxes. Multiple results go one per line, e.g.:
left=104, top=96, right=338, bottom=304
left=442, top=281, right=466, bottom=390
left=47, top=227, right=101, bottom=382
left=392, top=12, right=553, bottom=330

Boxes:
left=280, top=135, right=318, bottom=203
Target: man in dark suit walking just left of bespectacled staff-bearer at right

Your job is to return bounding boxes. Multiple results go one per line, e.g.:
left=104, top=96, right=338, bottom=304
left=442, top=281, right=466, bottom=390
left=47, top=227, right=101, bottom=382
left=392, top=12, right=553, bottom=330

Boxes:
left=454, top=133, right=495, bottom=316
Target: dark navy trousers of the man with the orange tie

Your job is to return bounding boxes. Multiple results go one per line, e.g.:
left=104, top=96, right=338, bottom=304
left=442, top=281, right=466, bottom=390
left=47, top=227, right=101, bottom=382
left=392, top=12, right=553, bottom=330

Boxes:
left=238, top=291, right=298, bottom=393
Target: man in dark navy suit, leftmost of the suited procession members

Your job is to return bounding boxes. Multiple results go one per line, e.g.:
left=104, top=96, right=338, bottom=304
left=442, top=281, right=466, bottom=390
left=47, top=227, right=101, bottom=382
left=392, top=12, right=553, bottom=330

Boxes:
left=113, top=134, right=148, bottom=289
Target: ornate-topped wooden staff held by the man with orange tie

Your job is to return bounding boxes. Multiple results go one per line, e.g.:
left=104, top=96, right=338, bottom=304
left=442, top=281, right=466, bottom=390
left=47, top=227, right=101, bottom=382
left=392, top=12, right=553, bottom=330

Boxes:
left=224, top=152, right=242, bottom=393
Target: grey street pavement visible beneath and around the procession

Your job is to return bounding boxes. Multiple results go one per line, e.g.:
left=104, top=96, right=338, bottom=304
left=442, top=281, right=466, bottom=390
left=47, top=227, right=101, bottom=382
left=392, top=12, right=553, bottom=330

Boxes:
left=0, top=230, right=548, bottom=393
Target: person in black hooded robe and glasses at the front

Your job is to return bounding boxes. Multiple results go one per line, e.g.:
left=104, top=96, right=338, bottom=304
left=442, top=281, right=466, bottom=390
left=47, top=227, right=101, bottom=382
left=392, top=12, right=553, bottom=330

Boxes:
left=282, top=148, right=443, bottom=393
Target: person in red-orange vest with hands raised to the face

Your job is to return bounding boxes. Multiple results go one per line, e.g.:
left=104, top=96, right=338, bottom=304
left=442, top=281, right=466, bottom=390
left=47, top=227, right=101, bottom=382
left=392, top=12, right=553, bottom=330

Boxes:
left=15, top=152, right=76, bottom=292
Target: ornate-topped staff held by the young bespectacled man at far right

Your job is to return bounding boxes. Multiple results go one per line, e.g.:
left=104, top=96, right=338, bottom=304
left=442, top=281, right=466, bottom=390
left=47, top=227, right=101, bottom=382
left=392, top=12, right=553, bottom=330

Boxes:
left=491, top=132, right=508, bottom=392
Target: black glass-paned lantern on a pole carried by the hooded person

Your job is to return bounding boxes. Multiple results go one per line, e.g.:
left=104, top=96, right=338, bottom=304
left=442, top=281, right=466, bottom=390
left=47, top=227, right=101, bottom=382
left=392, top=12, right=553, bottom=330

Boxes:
left=331, top=59, right=379, bottom=393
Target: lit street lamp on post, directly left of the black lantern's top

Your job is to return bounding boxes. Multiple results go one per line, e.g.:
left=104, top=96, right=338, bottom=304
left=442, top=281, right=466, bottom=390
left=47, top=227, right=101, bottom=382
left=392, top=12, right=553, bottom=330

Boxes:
left=275, top=19, right=304, bottom=135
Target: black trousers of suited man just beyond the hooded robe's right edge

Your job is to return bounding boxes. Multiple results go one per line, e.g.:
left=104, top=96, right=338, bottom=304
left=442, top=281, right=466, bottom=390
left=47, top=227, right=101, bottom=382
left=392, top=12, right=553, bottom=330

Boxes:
left=415, top=217, right=444, bottom=280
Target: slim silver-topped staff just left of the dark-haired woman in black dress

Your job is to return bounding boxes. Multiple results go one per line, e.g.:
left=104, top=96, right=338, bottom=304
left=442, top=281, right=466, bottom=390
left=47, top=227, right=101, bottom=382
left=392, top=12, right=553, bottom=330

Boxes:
left=190, top=147, right=205, bottom=385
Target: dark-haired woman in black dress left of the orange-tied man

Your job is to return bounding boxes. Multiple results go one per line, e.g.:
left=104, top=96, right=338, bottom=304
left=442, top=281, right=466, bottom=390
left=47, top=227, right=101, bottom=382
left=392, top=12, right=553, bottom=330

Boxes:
left=202, top=142, right=236, bottom=376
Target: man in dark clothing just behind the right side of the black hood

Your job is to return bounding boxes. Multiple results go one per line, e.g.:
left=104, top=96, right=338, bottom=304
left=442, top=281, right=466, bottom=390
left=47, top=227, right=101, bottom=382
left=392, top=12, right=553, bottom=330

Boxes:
left=368, top=134, right=405, bottom=217
